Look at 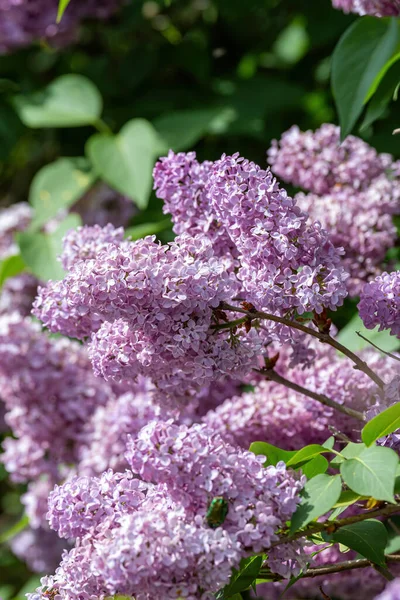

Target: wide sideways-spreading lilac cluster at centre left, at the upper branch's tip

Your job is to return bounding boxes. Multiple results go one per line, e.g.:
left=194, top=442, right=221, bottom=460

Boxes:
left=34, top=226, right=261, bottom=402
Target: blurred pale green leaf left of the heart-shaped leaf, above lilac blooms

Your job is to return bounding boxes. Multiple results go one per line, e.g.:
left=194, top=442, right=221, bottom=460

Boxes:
left=29, top=158, right=95, bottom=230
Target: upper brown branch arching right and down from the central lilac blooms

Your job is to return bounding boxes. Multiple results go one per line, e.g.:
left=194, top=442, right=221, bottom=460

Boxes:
left=214, top=302, right=384, bottom=389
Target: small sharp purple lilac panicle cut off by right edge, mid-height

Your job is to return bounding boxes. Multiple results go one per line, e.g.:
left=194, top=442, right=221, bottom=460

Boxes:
left=358, top=271, right=400, bottom=338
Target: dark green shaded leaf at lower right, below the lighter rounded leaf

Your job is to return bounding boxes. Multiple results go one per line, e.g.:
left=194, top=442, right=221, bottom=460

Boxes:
left=330, top=519, right=388, bottom=565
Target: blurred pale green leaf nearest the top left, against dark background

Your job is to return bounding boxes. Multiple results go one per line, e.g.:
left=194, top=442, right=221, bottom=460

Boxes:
left=13, top=75, right=103, bottom=128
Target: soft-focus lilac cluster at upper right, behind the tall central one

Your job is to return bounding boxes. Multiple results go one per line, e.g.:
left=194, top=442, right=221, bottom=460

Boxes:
left=268, top=124, right=400, bottom=295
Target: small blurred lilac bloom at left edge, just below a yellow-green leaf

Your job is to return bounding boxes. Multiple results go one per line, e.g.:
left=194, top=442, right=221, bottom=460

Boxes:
left=0, top=273, right=39, bottom=317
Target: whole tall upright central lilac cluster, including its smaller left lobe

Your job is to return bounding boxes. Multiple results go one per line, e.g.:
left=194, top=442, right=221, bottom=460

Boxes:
left=154, top=151, right=346, bottom=314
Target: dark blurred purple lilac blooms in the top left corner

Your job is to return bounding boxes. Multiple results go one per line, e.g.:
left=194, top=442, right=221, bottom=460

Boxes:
left=0, top=0, right=122, bottom=53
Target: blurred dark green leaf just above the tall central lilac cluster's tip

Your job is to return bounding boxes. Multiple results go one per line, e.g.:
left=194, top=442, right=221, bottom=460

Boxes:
left=153, top=108, right=226, bottom=152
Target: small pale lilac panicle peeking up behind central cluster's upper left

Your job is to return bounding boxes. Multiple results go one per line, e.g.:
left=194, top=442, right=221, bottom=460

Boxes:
left=61, top=223, right=124, bottom=270
